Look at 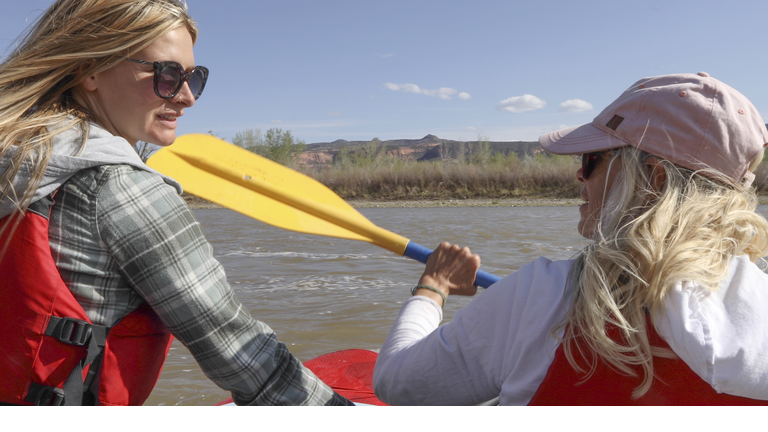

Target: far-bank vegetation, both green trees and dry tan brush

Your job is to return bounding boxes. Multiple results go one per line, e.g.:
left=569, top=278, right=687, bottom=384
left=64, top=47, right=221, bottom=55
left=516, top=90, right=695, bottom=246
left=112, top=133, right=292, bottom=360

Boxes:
left=184, top=129, right=768, bottom=209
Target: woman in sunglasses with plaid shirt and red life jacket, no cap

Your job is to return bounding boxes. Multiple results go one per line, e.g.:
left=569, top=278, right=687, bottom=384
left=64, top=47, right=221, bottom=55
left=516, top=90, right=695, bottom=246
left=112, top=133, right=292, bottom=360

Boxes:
left=0, top=0, right=350, bottom=405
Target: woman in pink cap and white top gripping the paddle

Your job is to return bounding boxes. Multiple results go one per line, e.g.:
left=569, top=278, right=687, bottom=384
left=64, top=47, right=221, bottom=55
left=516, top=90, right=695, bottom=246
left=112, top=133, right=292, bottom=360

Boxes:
left=374, top=73, right=768, bottom=405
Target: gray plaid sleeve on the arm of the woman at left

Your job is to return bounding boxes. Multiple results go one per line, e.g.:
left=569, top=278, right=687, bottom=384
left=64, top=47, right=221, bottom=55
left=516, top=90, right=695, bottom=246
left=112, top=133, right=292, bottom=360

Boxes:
left=97, top=165, right=351, bottom=405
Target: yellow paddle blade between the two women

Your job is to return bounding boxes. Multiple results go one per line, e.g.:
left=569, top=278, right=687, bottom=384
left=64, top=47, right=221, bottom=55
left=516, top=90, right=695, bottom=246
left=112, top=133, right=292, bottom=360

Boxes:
left=147, top=134, right=408, bottom=251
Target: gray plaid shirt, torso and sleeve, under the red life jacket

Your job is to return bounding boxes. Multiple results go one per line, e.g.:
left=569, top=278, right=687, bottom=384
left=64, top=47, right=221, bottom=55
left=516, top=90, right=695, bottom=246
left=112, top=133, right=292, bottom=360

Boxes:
left=45, top=165, right=351, bottom=405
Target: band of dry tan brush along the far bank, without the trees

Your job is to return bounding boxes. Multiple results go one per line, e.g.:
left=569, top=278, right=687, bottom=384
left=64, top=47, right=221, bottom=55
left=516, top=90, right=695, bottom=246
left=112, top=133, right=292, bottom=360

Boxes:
left=185, top=148, right=583, bottom=208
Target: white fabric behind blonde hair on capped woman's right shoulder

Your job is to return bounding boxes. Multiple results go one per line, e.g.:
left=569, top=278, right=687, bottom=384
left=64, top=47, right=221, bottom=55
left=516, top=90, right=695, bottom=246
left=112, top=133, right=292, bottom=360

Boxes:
left=654, top=256, right=768, bottom=400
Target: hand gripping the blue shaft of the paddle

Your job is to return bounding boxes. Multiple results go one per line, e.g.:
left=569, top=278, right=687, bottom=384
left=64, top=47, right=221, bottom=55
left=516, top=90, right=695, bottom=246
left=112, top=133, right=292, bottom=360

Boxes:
left=419, top=242, right=480, bottom=295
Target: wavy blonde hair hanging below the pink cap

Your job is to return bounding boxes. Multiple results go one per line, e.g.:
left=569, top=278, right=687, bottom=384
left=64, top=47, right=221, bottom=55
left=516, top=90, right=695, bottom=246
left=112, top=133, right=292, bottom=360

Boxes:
left=553, top=147, right=768, bottom=398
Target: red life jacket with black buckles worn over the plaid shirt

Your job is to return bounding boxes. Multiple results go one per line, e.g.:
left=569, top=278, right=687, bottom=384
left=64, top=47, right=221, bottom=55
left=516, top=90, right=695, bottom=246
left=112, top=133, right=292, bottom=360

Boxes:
left=0, top=198, right=172, bottom=405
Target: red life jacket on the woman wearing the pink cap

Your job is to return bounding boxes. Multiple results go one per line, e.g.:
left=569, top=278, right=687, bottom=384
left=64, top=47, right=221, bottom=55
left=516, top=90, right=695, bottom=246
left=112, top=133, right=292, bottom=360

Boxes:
left=529, top=319, right=768, bottom=405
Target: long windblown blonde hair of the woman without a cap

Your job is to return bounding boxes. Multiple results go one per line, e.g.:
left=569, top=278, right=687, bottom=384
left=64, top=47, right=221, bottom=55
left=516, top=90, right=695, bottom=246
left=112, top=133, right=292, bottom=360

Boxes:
left=0, top=0, right=197, bottom=219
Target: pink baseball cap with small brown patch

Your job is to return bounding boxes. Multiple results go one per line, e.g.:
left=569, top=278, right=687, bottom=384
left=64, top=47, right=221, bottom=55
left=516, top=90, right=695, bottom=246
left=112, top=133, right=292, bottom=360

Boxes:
left=539, top=72, right=768, bottom=186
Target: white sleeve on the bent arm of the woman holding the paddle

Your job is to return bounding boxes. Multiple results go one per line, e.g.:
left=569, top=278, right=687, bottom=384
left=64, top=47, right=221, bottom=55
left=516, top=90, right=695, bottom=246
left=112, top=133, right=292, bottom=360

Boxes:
left=373, top=258, right=572, bottom=405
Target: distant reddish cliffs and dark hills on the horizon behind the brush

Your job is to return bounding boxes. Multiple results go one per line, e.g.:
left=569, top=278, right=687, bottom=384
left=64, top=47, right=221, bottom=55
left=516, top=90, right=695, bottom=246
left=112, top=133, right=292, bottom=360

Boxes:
left=298, top=135, right=544, bottom=166
